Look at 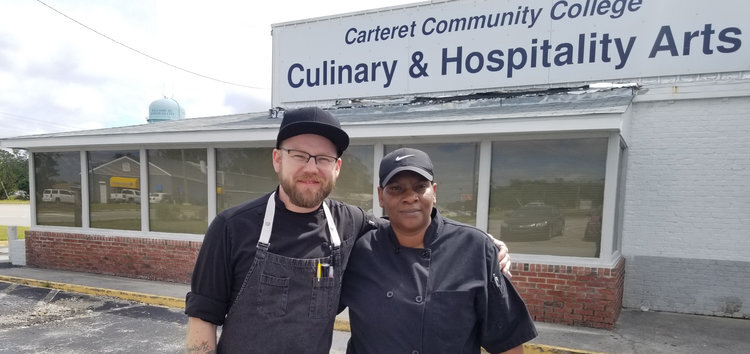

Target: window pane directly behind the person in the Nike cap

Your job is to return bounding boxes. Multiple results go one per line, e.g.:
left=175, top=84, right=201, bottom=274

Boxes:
left=385, top=143, right=478, bottom=224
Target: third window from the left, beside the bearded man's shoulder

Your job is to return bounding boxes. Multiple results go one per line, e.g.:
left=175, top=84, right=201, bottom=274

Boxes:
left=148, top=149, right=208, bottom=234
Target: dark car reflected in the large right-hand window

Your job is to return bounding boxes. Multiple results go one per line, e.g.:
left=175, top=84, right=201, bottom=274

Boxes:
left=500, top=203, right=565, bottom=241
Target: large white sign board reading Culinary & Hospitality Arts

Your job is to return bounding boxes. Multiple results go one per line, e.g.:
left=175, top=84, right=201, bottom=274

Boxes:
left=273, top=0, right=750, bottom=106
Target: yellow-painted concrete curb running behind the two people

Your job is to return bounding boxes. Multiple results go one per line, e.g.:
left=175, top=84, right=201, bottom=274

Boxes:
left=0, top=275, right=602, bottom=354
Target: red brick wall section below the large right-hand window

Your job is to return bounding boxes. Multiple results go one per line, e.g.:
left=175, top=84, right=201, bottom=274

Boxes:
left=511, top=258, right=625, bottom=328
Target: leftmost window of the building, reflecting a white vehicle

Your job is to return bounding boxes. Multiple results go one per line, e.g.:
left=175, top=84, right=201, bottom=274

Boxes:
left=34, top=151, right=81, bottom=227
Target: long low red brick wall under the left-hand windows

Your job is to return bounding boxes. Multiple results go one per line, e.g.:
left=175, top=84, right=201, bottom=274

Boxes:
left=26, top=230, right=201, bottom=284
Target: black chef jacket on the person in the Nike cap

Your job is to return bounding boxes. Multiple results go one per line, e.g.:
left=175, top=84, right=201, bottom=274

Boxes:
left=341, top=209, right=537, bottom=353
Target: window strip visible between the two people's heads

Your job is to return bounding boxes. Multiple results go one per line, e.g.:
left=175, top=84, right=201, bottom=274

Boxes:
left=330, top=145, right=374, bottom=212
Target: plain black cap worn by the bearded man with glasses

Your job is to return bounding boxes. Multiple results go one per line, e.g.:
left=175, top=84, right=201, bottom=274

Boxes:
left=276, top=107, right=349, bottom=156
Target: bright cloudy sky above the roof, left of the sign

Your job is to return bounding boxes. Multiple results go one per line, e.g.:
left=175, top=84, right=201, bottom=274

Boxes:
left=0, top=0, right=418, bottom=138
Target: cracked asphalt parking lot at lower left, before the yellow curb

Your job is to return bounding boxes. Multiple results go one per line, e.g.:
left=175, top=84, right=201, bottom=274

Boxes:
left=0, top=282, right=187, bottom=353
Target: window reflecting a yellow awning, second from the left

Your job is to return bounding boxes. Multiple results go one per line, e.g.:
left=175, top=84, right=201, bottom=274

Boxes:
left=88, top=150, right=143, bottom=230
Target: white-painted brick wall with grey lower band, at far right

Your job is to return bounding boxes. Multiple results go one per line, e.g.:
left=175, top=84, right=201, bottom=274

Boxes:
left=622, top=92, right=750, bottom=318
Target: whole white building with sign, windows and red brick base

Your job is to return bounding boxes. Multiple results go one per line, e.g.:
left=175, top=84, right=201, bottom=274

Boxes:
left=0, top=0, right=750, bottom=327
